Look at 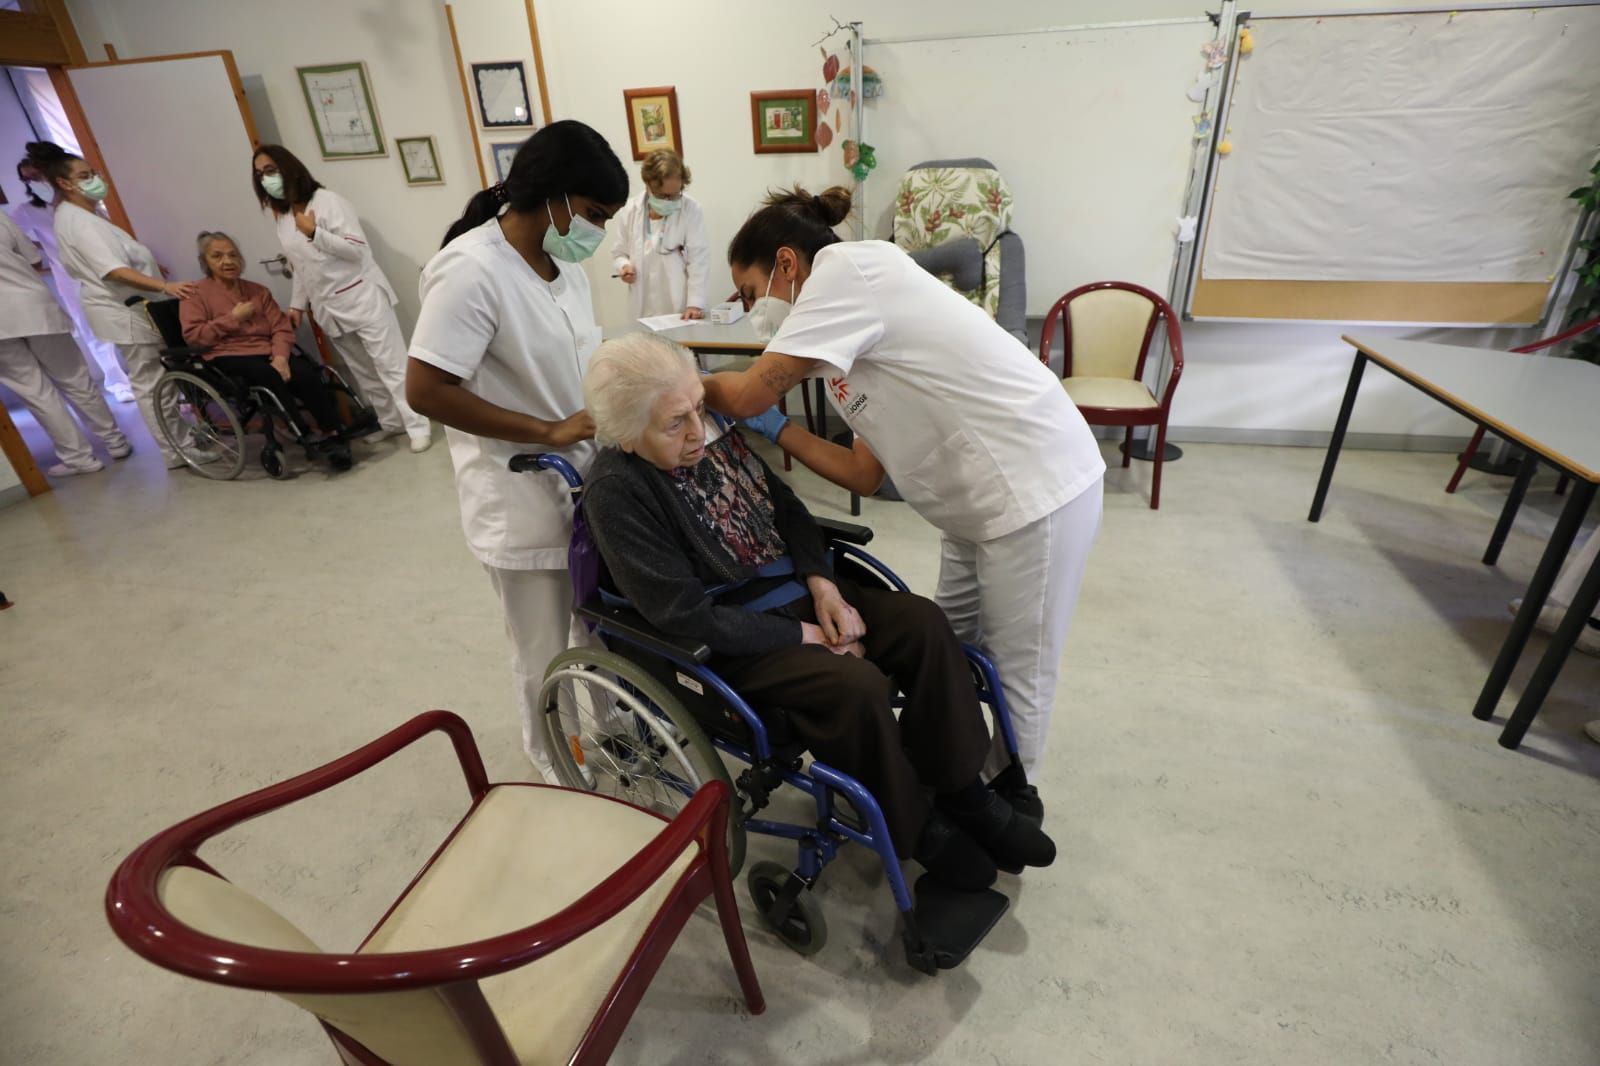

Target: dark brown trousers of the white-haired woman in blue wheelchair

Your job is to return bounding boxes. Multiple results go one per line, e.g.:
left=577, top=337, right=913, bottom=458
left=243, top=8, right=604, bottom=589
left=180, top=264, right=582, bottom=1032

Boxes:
left=712, top=579, right=989, bottom=858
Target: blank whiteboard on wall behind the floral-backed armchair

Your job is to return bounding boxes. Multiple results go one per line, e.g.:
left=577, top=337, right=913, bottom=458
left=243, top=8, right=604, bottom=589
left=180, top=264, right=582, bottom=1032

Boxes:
left=866, top=19, right=1214, bottom=315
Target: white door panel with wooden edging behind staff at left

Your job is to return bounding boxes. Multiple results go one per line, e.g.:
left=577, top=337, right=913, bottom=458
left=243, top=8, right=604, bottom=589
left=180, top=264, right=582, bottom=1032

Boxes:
left=67, top=54, right=290, bottom=307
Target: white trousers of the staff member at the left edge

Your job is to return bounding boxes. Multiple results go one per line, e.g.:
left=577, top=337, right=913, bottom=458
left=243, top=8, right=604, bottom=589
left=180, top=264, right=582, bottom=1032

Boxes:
left=0, top=333, right=128, bottom=467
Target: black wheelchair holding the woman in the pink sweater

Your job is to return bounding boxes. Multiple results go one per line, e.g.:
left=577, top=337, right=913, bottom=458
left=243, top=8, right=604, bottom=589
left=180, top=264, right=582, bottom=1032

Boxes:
left=128, top=296, right=378, bottom=482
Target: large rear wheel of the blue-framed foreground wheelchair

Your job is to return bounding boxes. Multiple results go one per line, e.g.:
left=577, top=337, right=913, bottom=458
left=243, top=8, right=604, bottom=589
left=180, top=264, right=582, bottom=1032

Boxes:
left=539, top=648, right=744, bottom=874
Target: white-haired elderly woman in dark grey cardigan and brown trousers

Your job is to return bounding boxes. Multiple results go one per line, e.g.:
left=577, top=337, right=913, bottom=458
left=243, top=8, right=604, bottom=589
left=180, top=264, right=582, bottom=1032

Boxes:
left=584, top=333, right=1056, bottom=890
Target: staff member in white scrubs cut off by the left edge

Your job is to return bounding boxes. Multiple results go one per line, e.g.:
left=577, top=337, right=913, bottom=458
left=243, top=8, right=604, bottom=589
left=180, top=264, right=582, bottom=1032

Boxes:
left=0, top=213, right=133, bottom=477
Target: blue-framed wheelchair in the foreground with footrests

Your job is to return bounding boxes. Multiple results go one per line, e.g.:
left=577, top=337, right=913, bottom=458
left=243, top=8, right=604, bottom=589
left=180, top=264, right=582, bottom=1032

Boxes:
left=510, top=455, right=1021, bottom=973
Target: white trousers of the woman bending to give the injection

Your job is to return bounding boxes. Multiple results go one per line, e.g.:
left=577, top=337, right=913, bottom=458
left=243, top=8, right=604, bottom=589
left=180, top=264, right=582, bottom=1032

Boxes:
left=934, top=479, right=1104, bottom=778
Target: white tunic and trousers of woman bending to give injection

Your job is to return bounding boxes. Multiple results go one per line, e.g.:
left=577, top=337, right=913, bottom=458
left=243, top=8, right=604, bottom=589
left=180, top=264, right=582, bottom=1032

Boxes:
left=768, top=240, right=1106, bottom=770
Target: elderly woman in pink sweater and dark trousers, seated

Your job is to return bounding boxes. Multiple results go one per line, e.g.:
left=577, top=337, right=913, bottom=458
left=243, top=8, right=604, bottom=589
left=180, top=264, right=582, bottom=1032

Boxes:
left=179, top=230, right=354, bottom=469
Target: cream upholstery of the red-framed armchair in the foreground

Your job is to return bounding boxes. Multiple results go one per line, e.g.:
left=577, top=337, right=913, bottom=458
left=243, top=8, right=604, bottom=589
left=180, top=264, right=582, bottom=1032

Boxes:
left=158, top=784, right=696, bottom=1066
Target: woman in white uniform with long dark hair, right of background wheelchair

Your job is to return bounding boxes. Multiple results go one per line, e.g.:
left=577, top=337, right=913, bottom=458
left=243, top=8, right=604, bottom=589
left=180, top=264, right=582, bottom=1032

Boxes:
left=250, top=144, right=434, bottom=451
